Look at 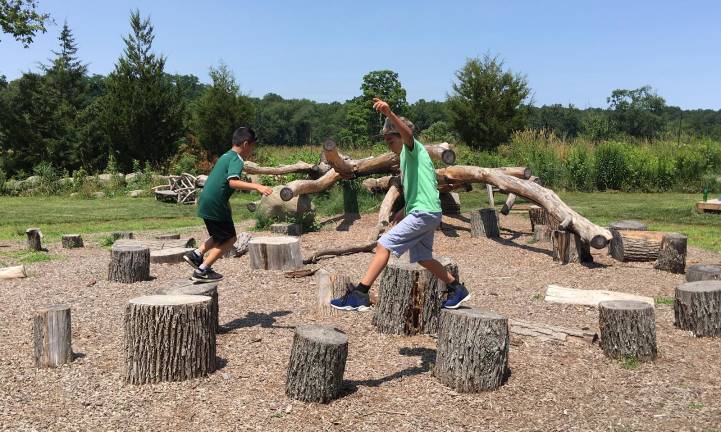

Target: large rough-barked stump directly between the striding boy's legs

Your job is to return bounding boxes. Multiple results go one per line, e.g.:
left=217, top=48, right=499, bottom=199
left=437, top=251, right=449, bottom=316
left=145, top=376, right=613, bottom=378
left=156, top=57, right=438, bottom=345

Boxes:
left=373, top=257, right=458, bottom=335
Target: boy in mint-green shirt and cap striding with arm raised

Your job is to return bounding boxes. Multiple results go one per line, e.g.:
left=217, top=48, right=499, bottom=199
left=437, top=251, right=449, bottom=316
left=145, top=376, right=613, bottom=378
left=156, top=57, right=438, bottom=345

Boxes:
left=330, top=98, right=471, bottom=311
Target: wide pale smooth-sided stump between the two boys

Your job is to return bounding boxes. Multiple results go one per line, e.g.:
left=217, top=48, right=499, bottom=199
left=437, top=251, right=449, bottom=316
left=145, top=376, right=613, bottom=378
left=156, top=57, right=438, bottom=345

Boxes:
left=248, top=237, right=303, bottom=270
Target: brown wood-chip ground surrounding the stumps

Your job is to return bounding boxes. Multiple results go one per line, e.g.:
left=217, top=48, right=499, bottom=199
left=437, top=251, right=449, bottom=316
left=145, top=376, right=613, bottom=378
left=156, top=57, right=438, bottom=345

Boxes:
left=0, top=215, right=721, bottom=431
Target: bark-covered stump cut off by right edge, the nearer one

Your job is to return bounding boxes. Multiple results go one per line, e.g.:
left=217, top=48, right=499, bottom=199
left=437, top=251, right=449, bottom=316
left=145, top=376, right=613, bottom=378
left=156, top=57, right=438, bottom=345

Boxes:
left=673, top=280, right=721, bottom=337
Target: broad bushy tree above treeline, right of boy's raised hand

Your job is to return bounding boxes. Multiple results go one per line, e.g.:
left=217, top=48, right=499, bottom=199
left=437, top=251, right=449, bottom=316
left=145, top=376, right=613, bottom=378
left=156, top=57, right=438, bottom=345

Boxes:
left=447, top=55, right=530, bottom=150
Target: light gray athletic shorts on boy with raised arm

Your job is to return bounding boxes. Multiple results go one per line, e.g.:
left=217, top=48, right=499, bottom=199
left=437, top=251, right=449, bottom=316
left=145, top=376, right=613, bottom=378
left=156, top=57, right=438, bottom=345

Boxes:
left=378, top=210, right=441, bottom=263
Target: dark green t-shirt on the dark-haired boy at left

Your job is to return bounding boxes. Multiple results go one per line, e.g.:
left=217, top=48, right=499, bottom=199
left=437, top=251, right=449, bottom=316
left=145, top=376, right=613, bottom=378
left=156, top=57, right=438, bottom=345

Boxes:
left=198, top=150, right=243, bottom=222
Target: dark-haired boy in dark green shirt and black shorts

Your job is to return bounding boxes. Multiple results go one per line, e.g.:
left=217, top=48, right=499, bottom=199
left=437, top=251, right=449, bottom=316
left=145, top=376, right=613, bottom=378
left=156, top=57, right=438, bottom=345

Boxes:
left=183, top=127, right=273, bottom=282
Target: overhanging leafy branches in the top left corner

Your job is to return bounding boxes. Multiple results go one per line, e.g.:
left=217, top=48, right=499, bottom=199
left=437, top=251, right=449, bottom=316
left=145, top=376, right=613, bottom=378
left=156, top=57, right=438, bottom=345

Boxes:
left=0, top=0, right=51, bottom=48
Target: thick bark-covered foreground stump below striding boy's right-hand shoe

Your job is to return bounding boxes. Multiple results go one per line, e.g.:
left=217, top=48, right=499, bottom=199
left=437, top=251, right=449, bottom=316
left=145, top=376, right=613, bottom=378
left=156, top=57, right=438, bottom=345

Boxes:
left=433, top=308, right=510, bottom=393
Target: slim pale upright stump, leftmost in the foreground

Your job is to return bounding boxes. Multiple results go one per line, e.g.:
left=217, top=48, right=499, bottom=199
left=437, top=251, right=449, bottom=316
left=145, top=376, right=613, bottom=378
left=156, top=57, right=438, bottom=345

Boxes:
left=33, top=305, right=73, bottom=367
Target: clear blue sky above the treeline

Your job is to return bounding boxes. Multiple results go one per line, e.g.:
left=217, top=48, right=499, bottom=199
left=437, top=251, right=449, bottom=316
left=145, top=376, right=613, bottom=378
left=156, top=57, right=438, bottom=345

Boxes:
left=0, top=0, right=721, bottom=109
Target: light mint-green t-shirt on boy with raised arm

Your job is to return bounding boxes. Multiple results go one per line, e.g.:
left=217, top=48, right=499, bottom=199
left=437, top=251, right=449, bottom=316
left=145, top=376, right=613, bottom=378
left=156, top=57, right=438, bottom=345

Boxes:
left=401, top=138, right=441, bottom=214
